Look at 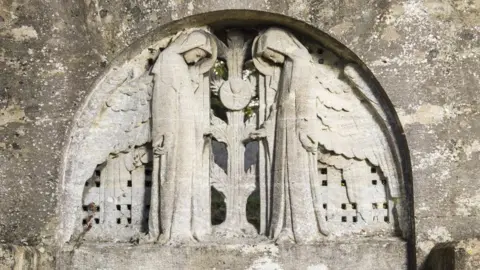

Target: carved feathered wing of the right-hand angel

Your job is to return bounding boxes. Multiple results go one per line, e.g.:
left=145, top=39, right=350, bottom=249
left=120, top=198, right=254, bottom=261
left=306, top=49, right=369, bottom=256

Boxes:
left=314, top=64, right=401, bottom=197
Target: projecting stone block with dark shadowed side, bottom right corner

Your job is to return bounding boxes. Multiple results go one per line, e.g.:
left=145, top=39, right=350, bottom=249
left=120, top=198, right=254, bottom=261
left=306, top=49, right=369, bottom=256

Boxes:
left=422, top=239, right=480, bottom=270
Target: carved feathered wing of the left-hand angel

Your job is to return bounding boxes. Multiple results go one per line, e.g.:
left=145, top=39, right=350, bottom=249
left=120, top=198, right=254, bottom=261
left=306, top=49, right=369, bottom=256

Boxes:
left=85, top=72, right=153, bottom=167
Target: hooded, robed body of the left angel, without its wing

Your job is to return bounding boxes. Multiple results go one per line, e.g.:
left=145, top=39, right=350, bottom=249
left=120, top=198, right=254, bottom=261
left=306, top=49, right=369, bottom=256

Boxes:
left=149, top=30, right=216, bottom=242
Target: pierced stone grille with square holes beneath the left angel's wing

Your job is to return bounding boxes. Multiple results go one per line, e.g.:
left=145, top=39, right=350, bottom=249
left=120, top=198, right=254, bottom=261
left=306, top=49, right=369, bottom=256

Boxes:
left=81, top=154, right=152, bottom=241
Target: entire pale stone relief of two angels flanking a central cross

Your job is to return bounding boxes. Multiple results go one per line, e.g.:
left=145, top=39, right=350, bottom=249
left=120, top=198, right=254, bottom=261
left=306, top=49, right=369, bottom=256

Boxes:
left=78, top=27, right=403, bottom=244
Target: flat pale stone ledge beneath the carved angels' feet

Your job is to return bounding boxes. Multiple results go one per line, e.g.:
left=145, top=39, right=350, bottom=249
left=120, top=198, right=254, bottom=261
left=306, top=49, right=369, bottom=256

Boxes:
left=57, top=239, right=407, bottom=270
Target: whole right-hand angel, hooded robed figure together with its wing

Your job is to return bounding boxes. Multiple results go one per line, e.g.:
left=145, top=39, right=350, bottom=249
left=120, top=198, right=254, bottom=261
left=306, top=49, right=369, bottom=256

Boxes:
left=251, top=28, right=399, bottom=243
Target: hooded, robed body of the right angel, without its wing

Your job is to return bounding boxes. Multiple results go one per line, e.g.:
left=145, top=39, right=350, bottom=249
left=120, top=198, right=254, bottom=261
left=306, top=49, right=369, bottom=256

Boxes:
left=254, top=28, right=326, bottom=243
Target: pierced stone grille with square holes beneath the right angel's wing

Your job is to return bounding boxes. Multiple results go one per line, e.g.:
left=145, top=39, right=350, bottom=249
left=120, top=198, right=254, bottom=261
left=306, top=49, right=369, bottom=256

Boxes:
left=316, top=163, right=394, bottom=235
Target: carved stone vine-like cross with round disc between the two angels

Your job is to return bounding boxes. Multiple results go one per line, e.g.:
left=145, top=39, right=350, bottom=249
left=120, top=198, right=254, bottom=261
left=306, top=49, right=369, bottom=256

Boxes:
left=211, top=31, right=256, bottom=236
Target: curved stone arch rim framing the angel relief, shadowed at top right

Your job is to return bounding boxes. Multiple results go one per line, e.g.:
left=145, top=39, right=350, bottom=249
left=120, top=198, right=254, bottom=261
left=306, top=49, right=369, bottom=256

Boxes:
left=57, top=10, right=414, bottom=262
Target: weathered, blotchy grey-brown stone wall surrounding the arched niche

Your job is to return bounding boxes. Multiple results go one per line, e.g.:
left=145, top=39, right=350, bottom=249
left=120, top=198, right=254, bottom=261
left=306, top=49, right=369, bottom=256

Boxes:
left=0, top=0, right=480, bottom=264
